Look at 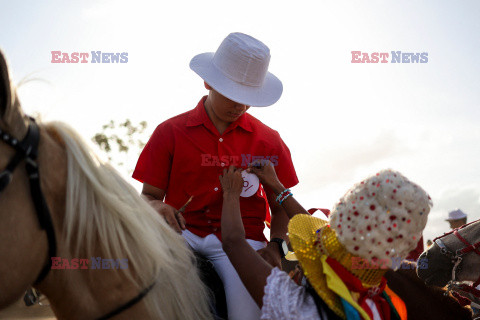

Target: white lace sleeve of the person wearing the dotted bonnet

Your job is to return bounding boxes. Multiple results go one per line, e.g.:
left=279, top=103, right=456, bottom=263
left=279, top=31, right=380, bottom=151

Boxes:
left=261, top=268, right=326, bottom=320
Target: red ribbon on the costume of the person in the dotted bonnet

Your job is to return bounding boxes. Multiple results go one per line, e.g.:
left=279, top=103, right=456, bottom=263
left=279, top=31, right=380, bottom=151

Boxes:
left=327, top=257, right=390, bottom=320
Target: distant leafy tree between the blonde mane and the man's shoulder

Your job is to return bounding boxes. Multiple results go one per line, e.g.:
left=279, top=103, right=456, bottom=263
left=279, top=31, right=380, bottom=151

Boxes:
left=92, top=119, right=147, bottom=174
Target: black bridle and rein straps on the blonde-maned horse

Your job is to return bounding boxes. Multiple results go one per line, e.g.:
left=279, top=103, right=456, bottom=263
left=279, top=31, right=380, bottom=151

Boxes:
left=0, top=118, right=155, bottom=320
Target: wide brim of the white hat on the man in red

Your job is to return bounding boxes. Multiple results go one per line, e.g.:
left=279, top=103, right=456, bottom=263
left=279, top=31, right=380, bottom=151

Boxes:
left=190, top=52, right=283, bottom=107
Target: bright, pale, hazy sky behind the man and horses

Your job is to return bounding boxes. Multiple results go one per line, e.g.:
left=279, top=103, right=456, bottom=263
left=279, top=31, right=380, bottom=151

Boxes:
left=0, top=0, right=480, bottom=244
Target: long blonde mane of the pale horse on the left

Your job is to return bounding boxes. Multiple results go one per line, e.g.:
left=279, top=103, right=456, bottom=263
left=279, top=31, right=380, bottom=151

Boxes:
left=46, top=122, right=212, bottom=320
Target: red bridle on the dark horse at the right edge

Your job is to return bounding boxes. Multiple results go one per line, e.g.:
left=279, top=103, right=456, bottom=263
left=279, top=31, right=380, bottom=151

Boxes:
left=433, top=220, right=480, bottom=305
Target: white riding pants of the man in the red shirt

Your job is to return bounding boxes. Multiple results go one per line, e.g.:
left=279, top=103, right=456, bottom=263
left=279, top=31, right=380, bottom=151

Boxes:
left=182, top=230, right=266, bottom=320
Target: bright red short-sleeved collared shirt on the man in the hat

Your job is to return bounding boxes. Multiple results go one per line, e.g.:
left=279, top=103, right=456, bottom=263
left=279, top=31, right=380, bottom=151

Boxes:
left=133, top=96, right=298, bottom=241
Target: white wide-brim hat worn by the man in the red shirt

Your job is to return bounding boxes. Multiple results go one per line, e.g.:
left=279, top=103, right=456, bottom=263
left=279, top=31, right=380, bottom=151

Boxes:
left=190, top=33, right=283, bottom=107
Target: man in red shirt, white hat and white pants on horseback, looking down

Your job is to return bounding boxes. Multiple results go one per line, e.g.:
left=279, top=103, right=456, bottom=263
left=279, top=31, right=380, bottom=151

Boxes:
left=133, top=33, right=298, bottom=320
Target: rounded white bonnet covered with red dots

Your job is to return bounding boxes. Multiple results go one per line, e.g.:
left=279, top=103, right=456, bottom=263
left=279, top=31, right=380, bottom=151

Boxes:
left=330, top=170, right=432, bottom=266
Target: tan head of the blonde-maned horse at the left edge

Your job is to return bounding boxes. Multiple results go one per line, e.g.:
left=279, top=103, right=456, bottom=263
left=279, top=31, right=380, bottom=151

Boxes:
left=0, top=51, right=66, bottom=309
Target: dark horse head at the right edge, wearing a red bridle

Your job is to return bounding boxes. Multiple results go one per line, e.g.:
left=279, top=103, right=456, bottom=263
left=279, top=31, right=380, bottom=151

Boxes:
left=417, top=221, right=480, bottom=287
